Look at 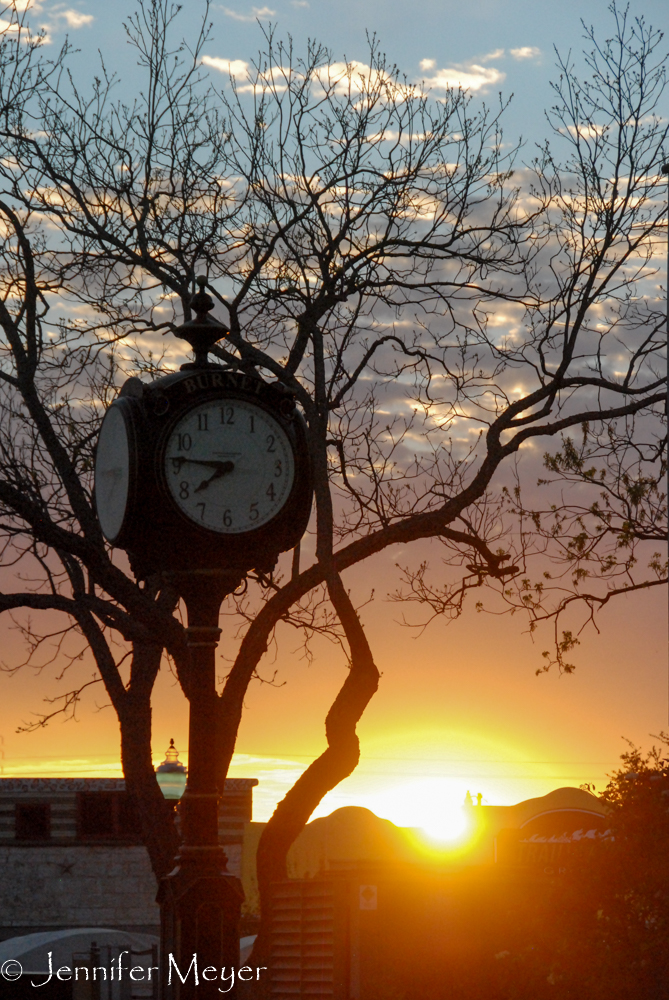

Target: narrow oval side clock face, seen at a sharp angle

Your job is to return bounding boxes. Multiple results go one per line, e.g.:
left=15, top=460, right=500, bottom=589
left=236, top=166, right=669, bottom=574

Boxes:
left=95, top=406, right=130, bottom=542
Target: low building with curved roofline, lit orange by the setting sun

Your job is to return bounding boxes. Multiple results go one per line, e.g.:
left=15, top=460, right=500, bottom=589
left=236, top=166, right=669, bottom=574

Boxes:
left=264, top=788, right=606, bottom=1000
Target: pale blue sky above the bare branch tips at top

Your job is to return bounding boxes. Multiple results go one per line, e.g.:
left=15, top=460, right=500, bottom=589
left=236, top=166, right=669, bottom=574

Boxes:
left=24, top=0, right=669, bottom=156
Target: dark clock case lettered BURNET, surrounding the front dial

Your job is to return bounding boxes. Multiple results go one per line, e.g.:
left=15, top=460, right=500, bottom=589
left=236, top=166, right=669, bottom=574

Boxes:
left=96, top=364, right=313, bottom=579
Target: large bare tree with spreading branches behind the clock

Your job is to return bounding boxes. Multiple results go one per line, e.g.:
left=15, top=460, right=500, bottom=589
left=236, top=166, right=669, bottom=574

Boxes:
left=0, top=0, right=665, bottom=947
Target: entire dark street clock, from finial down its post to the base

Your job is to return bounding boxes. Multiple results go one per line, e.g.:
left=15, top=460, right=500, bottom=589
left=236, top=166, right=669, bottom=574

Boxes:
left=95, top=278, right=313, bottom=1000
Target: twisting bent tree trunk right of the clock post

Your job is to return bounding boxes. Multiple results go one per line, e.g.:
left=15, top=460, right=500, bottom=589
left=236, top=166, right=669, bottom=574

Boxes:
left=253, top=573, right=379, bottom=961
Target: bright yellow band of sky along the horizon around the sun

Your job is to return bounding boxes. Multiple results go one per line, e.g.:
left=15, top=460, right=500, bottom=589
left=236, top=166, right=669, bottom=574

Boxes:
left=2, top=726, right=620, bottom=832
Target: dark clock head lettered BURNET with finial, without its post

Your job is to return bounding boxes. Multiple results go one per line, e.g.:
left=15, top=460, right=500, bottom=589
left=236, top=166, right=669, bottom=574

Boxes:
left=95, top=282, right=312, bottom=578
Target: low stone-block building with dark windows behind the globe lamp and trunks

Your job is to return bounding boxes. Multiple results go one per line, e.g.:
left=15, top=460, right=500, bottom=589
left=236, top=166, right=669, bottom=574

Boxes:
left=0, top=778, right=258, bottom=940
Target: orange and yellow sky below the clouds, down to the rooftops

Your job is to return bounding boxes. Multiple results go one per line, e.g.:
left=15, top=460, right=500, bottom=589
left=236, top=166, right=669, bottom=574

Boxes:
left=0, top=552, right=669, bottom=832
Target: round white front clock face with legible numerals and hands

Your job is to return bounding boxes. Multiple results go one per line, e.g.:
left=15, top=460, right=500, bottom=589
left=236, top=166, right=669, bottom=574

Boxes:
left=165, top=399, right=295, bottom=535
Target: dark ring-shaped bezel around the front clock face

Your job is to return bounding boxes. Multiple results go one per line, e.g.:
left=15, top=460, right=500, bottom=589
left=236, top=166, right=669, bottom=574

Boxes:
left=157, top=389, right=299, bottom=543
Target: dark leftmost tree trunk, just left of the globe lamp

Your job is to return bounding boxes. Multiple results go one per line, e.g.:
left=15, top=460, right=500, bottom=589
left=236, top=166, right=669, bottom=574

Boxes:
left=119, top=643, right=179, bottom=879
